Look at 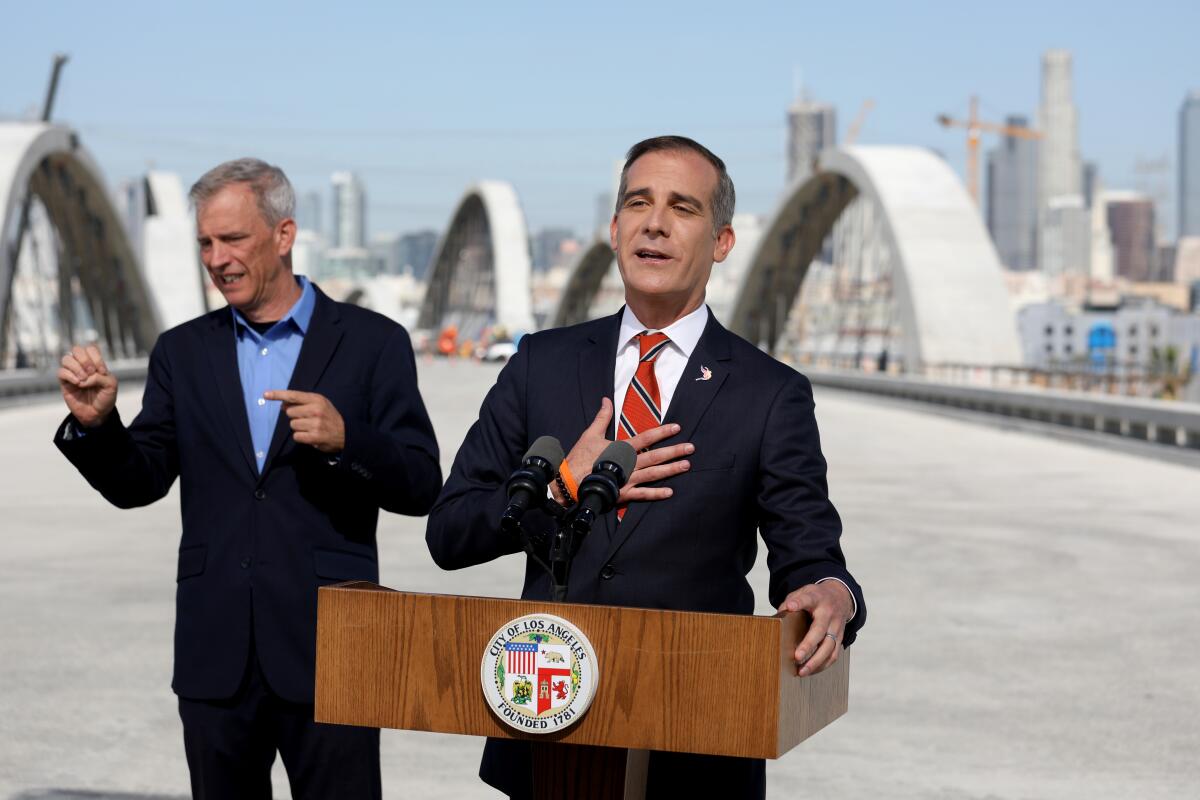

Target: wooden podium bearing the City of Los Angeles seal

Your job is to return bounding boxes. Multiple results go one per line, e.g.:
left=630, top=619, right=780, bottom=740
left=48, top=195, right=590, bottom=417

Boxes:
left=316, top=582, right=850, bottom=798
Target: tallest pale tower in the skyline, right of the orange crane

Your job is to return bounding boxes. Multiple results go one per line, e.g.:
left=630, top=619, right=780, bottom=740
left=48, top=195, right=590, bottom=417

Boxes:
left=1038, top=50, right=1091, bottom=275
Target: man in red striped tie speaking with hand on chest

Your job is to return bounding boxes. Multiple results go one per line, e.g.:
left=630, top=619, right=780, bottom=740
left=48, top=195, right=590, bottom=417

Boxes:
left=426, top=137, right=865, bottom=798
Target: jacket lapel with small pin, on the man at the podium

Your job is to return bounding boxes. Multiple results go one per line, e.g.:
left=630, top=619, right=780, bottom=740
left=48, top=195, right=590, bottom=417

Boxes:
left=605, top=311, right=731, bottom=561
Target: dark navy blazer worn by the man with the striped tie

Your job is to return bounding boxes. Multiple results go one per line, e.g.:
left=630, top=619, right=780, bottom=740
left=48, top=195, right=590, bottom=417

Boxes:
left=426, top=313, right=866, bottom=796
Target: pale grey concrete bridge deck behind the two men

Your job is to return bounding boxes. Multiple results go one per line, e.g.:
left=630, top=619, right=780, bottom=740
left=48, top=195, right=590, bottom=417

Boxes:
left=0, top=362, right=1200, bottom=800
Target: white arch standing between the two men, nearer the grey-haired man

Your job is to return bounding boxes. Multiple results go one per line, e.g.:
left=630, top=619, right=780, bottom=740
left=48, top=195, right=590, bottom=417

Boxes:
left=418, top=181, right=534, bottom=333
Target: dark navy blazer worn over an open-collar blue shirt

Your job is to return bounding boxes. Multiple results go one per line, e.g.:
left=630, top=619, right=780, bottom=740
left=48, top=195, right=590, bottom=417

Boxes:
left=55, top=287, right=442, bottom=703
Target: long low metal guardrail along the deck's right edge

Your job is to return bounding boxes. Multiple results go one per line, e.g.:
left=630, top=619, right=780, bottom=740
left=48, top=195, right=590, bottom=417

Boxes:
left=803, top=368, right=1200, bottom=450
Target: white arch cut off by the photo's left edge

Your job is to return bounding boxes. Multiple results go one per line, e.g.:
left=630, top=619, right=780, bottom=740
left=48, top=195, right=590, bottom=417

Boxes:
left=0, top=122, right=161, bottom=357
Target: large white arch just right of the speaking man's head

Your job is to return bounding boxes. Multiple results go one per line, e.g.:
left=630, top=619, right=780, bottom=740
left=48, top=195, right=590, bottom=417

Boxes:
left=730, top=146, right=1021, bottom=366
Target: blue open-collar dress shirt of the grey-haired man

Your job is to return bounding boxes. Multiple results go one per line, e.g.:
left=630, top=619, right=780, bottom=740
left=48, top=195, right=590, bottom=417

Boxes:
left=230, top=275, right=317, bottom=473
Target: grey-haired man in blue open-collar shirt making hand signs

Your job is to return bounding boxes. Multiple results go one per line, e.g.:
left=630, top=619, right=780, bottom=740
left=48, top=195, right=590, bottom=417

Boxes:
left=55, top=158, right=442, bottom=800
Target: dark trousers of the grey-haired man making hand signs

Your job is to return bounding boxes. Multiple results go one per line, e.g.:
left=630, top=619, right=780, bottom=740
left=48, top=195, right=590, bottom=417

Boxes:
left=179, top=652, right=382, bottom=800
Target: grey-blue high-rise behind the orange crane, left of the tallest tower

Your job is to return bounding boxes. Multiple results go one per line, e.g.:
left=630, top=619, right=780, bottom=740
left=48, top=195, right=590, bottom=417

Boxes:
left=988, top=115, right=1038, bottom=270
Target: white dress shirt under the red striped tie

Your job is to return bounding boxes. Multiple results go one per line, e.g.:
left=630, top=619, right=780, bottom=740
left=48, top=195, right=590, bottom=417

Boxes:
left=610, top=303, right=858, bottom=622
